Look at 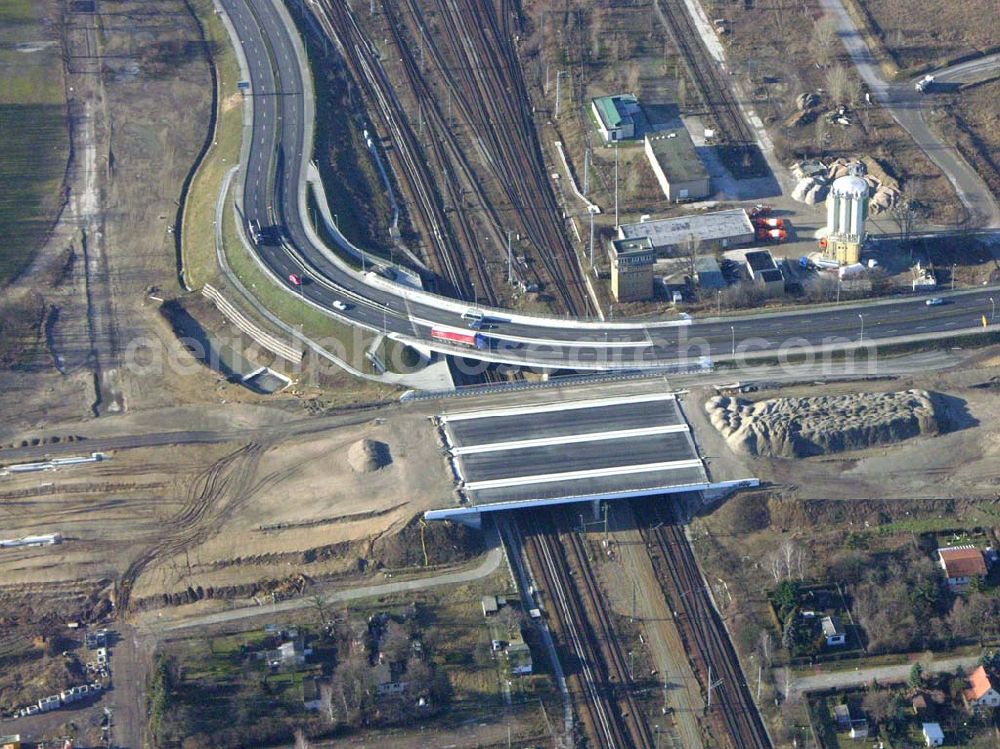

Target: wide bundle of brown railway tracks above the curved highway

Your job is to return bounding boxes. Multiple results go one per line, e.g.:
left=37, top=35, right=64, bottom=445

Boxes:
left=318, top=0, right=589, bottom=315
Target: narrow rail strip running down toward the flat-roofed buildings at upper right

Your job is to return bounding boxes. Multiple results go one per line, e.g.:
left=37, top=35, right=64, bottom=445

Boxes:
left=653, top=0, right=763, bottom=169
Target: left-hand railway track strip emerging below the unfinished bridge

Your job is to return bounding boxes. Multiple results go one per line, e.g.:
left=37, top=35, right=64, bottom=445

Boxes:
left=517, top=511, right=654, bottom=749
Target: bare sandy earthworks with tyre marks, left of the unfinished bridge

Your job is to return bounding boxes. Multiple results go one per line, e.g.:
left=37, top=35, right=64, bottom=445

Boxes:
left=0, top=404, right=454, bottom=606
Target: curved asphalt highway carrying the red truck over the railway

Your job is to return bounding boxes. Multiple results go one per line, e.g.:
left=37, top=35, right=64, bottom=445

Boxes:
left=213, top=0, right=1000, bottom=369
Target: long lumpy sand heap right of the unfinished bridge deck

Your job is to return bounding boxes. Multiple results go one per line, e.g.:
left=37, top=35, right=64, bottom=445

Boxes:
left=705, top=390, right=938, bottom=458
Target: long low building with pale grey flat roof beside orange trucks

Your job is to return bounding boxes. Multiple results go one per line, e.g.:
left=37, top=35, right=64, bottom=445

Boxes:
left=618, top=208, right=754, bottom=257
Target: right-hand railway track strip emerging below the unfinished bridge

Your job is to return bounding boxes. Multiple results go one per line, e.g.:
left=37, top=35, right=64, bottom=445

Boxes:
left=636, top=502, right=772, bottom=749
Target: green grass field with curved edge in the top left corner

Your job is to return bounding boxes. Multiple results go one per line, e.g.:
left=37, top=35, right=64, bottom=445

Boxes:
left=0, top=0, right=69, bottom=286
